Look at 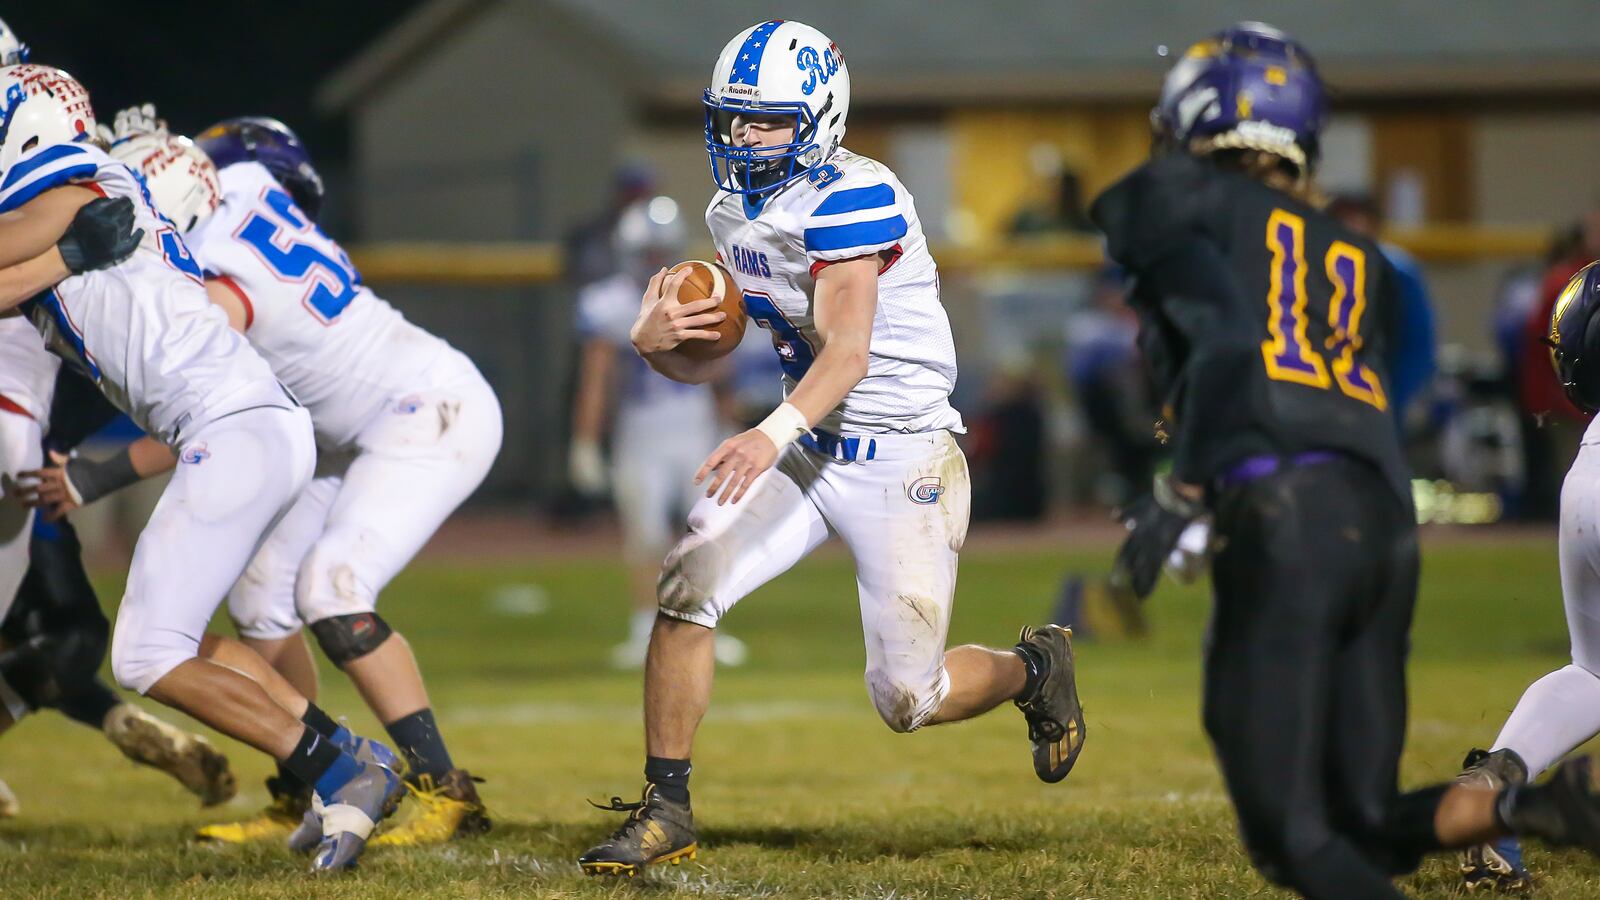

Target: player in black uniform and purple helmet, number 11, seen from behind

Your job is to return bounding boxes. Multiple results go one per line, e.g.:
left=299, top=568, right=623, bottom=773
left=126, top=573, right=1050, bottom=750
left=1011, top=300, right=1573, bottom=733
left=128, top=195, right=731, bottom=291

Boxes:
left=1091, top=22, right=1600, bottom=898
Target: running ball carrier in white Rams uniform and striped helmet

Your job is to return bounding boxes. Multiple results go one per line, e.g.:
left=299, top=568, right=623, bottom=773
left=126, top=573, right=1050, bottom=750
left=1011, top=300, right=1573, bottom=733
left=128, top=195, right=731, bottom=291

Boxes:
left=578, top=21, right=1085, bottom=874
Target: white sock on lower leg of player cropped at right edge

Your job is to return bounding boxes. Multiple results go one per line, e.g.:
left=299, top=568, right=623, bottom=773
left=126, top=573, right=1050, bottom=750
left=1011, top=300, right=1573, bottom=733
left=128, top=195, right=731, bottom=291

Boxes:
left=1491, top=666, right=1600, bottom=780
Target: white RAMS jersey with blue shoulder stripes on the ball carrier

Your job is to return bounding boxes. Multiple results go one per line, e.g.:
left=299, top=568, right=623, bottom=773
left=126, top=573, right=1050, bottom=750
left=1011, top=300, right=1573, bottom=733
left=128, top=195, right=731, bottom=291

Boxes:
left=706, top=151, right=963, bottom=434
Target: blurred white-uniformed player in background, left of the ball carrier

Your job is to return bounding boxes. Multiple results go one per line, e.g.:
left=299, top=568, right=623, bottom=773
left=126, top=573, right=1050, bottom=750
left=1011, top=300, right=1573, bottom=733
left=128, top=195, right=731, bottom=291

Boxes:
left=568, top=197, right=746, bottom=669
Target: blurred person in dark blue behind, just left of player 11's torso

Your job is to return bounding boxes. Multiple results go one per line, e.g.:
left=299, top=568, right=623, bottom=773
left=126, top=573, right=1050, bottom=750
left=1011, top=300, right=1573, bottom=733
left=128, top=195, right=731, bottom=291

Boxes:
left=1067, top=266, right=1162, bottom=506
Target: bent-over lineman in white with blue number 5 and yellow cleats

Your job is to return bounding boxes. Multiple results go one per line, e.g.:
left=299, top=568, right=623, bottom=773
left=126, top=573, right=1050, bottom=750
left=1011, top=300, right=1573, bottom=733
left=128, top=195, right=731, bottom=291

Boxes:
left=92, top=106, right=502, bottom=846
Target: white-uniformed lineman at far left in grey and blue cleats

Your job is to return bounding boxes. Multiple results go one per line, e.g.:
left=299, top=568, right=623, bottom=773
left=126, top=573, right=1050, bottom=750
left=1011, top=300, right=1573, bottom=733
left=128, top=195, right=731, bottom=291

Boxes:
left=0, top=66, right=403, bottom=871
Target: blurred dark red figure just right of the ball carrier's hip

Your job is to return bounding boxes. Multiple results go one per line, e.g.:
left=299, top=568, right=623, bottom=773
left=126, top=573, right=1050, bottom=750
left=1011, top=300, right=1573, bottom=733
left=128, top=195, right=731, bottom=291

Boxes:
left=966, top=365, right=1050, bottom=522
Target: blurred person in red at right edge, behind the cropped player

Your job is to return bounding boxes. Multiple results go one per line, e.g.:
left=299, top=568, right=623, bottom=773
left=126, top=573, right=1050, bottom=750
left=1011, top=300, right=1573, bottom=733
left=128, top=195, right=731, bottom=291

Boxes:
left=1517, top=205, right=1600, bottom=519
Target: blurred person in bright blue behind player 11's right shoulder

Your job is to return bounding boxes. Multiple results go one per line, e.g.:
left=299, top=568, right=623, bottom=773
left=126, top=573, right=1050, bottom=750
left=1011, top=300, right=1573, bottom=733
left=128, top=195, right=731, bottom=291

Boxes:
left=1328, top=194, right=1438, bottom=428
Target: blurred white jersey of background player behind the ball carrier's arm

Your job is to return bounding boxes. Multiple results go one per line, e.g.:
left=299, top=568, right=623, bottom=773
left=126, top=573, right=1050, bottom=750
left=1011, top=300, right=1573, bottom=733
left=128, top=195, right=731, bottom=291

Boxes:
left=578, top=272, right=717, bottom=439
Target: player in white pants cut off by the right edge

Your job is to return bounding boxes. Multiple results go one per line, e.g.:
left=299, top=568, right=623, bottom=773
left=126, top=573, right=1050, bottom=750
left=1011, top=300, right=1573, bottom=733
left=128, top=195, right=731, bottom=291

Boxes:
left=1458, top=263, right=1600, bottom=894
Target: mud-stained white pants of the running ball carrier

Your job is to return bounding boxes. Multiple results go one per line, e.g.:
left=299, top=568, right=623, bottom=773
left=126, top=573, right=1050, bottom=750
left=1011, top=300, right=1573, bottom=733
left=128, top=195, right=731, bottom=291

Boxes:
left=658, top=431, right=971, bottom=732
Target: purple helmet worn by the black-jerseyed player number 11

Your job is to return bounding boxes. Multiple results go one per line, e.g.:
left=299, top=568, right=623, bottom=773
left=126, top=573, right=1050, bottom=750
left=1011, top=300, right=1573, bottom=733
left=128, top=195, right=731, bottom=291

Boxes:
left=1150, top=22, right=1326, bottom=173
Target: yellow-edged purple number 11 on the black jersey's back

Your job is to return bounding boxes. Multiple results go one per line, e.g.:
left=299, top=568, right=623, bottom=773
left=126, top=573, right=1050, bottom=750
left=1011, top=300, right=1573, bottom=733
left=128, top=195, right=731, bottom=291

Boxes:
left=1261, top=210, right=1389, bottom=410
